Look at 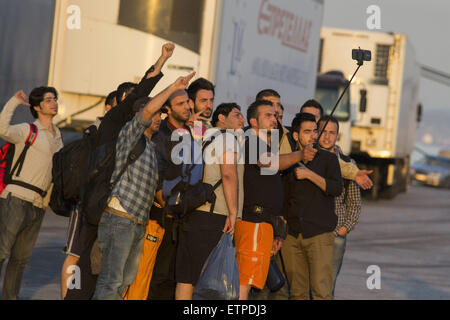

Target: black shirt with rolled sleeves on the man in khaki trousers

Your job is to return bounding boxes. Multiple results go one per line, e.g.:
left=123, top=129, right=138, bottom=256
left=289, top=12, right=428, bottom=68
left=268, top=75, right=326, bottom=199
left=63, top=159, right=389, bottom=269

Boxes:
left=285, top=150, right=342, bottom=238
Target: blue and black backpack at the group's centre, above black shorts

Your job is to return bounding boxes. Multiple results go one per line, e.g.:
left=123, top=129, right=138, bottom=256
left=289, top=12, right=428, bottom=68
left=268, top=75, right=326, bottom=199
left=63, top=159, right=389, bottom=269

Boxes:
left=162, top=130, right=225, bottom=219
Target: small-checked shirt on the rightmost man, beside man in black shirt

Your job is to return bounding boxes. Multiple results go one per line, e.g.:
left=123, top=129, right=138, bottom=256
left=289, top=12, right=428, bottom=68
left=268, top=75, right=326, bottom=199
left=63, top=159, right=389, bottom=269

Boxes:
left=334, top=180, right=361, bottom=236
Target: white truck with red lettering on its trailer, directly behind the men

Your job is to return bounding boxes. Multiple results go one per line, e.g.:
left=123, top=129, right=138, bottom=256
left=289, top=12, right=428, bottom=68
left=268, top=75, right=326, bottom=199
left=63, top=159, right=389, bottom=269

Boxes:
left=42, top=0, right=324, bottom=127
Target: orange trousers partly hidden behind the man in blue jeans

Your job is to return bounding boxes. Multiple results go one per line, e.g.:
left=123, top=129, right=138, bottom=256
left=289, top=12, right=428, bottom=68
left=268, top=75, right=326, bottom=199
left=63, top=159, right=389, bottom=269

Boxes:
left=123, top=220, right=164, bottom=300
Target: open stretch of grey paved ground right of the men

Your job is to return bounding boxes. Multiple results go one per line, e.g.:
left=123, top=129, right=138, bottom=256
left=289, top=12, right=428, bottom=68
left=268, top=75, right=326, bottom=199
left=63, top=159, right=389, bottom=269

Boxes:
left=335, top=182, right=450, bottom=300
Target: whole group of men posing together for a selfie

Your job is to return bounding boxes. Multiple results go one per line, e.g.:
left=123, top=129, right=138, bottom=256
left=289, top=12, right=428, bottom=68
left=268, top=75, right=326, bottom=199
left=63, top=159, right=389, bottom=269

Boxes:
left=0, top=44, right=371, bottom=300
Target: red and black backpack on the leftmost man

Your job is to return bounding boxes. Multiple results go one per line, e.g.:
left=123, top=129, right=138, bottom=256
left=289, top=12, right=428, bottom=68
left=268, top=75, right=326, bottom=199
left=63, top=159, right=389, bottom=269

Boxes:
left=0, top=123, right=47, bottom=198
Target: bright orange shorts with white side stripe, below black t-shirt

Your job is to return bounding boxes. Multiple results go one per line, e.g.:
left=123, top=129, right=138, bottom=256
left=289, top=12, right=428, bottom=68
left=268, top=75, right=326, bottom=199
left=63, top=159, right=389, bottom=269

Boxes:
left=234, top=221, right=273, bottom=289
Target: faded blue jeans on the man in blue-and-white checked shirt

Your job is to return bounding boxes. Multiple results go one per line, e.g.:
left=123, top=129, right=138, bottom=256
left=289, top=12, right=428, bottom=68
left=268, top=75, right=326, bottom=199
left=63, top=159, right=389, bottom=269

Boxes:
left=93, top=213, right=145, bottom=300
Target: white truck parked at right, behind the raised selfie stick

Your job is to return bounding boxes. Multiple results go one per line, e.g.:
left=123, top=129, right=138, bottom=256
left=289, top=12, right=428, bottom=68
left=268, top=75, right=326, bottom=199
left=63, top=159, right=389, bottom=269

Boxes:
left=316, top=27, right=421, bottom=198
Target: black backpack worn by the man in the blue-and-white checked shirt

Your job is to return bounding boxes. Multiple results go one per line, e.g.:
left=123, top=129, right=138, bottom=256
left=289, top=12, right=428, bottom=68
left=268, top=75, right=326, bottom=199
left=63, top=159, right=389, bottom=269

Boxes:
left=80, top=135, right=147, bottom=226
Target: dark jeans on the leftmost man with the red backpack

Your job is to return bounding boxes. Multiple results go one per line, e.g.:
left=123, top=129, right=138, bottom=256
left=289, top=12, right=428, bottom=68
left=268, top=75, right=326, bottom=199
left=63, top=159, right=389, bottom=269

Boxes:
left=0, top=194, right=45, bottom=300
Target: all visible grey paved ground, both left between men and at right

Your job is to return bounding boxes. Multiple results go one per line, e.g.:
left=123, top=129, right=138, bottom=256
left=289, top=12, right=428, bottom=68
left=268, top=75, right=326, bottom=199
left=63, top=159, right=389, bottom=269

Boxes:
left=0, top=185, right=450, bottom=300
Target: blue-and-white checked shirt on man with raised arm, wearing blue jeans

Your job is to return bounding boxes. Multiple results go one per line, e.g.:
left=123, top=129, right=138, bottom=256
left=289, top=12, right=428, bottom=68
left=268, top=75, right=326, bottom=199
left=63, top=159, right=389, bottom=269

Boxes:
left=108, top=112, right=158, bottom=224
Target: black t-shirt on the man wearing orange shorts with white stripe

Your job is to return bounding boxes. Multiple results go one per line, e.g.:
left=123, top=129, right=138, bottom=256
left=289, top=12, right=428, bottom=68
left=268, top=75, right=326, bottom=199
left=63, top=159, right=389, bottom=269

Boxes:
left=242, top=132, right=283, bottom=223
